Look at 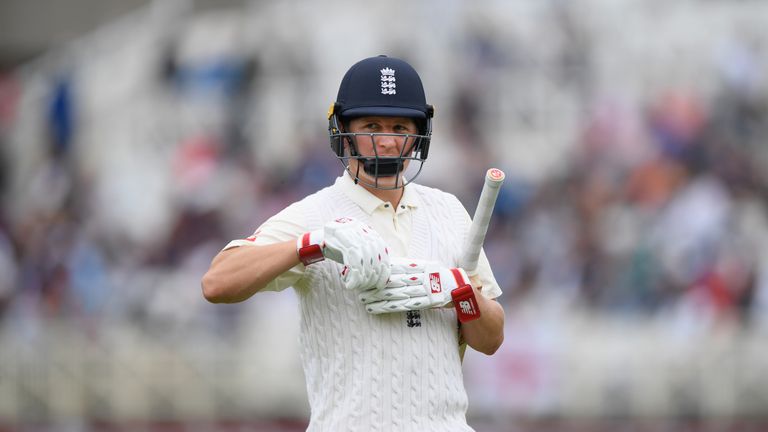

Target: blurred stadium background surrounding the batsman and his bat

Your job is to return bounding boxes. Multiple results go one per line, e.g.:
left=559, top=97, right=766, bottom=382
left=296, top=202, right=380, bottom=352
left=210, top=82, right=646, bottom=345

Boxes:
left=0, top=0, right=768, bottom=432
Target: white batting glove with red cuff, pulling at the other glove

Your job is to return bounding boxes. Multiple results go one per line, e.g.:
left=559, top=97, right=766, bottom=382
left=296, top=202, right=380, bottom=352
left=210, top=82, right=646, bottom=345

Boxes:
left=296, top=217, right=390, bottom=290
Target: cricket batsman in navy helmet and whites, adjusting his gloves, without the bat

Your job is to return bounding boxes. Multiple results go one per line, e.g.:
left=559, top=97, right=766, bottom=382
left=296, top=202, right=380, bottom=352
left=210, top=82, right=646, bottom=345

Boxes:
left=202, top=56, right=504, bottom=432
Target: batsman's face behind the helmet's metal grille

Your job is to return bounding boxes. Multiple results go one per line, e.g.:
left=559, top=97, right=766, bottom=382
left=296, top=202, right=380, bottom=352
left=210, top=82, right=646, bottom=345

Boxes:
left=348, top=117, right=419, bottom=183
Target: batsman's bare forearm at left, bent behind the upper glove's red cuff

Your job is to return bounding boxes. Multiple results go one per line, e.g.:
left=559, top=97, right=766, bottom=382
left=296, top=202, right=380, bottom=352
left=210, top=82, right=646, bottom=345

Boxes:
left=202, top=241, right=299, bottom=303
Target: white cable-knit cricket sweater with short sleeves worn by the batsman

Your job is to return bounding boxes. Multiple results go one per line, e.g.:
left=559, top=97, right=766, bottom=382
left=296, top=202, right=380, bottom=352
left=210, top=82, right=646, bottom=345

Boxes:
left=228, top=177, right=501, bottom=432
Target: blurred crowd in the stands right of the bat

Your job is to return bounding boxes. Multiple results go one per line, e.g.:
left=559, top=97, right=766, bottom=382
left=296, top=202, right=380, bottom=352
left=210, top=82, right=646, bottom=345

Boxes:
left=500, top=81, right=768, bottom=325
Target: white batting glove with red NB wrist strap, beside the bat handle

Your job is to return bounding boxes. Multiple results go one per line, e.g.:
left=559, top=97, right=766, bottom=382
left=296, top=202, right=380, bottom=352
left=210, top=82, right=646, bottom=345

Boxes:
left=358, top=258, right=480, bottom=322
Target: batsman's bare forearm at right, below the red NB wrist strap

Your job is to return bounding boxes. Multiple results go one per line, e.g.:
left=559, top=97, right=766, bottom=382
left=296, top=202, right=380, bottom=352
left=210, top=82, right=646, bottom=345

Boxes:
left=461, top=290, right=504, bottom=355
